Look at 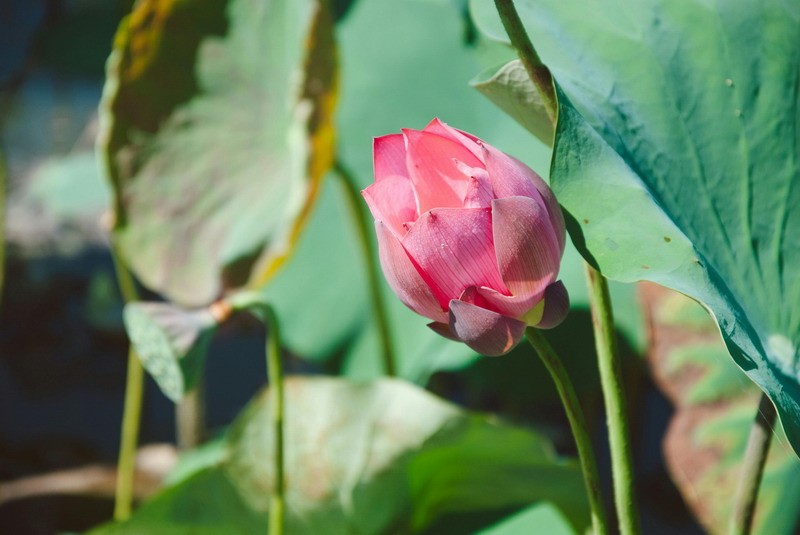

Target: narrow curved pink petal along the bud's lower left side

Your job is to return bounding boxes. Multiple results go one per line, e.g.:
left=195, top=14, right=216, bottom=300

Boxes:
left=375, top=221, right=447, bottom=323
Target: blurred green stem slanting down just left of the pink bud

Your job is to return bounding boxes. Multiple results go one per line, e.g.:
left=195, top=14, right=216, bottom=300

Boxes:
left=334, top=160, right=397, bottom=377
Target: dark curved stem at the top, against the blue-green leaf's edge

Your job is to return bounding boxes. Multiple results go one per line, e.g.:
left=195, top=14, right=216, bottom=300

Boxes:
left=494, top=0, right=558, bottom=124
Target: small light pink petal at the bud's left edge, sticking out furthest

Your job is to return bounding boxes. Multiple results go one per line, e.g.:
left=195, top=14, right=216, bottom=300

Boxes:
left=361, top=176, right=418, bottom=238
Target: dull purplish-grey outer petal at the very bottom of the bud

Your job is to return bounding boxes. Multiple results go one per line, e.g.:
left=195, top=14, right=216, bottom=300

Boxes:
left=450, top=299, right=525, bottom=357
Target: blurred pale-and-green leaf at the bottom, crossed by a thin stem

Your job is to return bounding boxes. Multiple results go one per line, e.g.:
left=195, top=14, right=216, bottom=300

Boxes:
left=95, top=378, right=589, bottom=535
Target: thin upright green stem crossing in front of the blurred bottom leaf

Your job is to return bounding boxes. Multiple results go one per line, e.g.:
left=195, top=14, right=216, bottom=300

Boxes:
left=261, top=305, right=285, bottom=535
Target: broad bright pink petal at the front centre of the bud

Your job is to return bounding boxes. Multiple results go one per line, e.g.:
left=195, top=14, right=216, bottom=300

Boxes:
left=403, top=208, right=505, bottom=303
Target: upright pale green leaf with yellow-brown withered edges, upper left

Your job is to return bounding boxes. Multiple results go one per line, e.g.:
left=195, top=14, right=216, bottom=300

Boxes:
left=99, top=0, right=335, bottom=306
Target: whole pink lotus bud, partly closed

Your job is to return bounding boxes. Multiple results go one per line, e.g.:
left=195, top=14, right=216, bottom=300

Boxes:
left=362, top=119, right=569, bottom=355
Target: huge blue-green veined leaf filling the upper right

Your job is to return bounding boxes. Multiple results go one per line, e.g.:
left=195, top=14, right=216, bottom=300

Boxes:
left=473, top=0, right=800, bottom=451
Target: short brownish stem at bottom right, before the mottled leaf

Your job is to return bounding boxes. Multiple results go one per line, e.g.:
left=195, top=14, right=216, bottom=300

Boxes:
left=728, top=394, right=776, bottom=535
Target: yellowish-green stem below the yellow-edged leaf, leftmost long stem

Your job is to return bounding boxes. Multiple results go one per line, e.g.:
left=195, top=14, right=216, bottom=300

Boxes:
left=111, top=243, right=144, bottom=521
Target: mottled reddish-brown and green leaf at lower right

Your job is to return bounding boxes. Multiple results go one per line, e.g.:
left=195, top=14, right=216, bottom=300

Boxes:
left=642, top=285, right=800, bottom=535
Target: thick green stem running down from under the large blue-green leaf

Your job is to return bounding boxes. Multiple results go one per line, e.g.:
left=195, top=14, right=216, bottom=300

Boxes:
left=584, top=264, right=641, bottom=535
